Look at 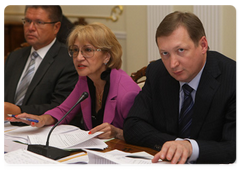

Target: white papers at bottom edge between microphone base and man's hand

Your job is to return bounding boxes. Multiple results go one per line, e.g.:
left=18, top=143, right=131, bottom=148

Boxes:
left=87, top=150, right=171, bottom=165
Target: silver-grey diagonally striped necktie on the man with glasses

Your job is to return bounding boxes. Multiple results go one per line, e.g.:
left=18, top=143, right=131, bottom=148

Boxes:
left=15, top=51, right=38, bottom=106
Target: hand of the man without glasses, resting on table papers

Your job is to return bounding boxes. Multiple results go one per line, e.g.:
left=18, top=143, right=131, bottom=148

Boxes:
left=152, top=140, right=192, bottom=165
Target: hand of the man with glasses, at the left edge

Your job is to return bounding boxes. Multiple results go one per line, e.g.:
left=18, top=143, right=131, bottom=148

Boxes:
left=2, top=101, right=21, bottom=120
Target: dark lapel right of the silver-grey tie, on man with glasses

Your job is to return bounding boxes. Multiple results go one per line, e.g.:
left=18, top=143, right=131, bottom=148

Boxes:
left=23, top=41, right=61, bottom=104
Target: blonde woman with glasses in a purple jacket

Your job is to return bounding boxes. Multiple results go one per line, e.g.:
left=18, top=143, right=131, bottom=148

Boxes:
left=10, top=23, right=140, bottom=140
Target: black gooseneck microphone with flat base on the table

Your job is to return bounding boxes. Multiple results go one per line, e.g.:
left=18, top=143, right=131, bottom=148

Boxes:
left=27, top=92, right=88, bottom=160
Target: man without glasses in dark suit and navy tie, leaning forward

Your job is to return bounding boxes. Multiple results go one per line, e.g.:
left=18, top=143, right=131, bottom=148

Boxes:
left=124, top=12, right=237, bottom=164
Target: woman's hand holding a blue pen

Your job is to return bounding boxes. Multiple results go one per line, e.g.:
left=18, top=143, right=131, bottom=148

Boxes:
left=7, top=113, right=56, bottom=127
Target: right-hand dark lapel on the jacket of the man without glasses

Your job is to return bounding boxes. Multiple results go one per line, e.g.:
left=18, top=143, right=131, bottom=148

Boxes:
left=191, top=56, right=221, bottom=138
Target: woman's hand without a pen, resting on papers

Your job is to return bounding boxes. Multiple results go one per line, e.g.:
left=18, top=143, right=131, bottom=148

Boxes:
left=89, top=123, right=124, bottom=140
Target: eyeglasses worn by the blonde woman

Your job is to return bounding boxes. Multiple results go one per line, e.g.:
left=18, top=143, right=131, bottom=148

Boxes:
left=68, top=45, right=102, bottom=58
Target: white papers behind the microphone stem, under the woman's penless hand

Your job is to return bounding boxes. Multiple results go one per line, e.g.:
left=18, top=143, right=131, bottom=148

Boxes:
left=28, top=129, right=107, bottom=149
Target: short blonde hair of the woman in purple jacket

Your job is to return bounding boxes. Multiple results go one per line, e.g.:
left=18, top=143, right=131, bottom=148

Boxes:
left=68, top=23, right=122, bottom=69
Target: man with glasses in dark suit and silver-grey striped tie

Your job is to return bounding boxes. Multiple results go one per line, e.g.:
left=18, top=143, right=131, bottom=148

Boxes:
left=2, top=3, right=78, bottom=120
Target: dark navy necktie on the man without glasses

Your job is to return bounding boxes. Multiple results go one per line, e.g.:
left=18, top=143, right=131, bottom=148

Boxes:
left=179, top=84, right=193, bottom=138
